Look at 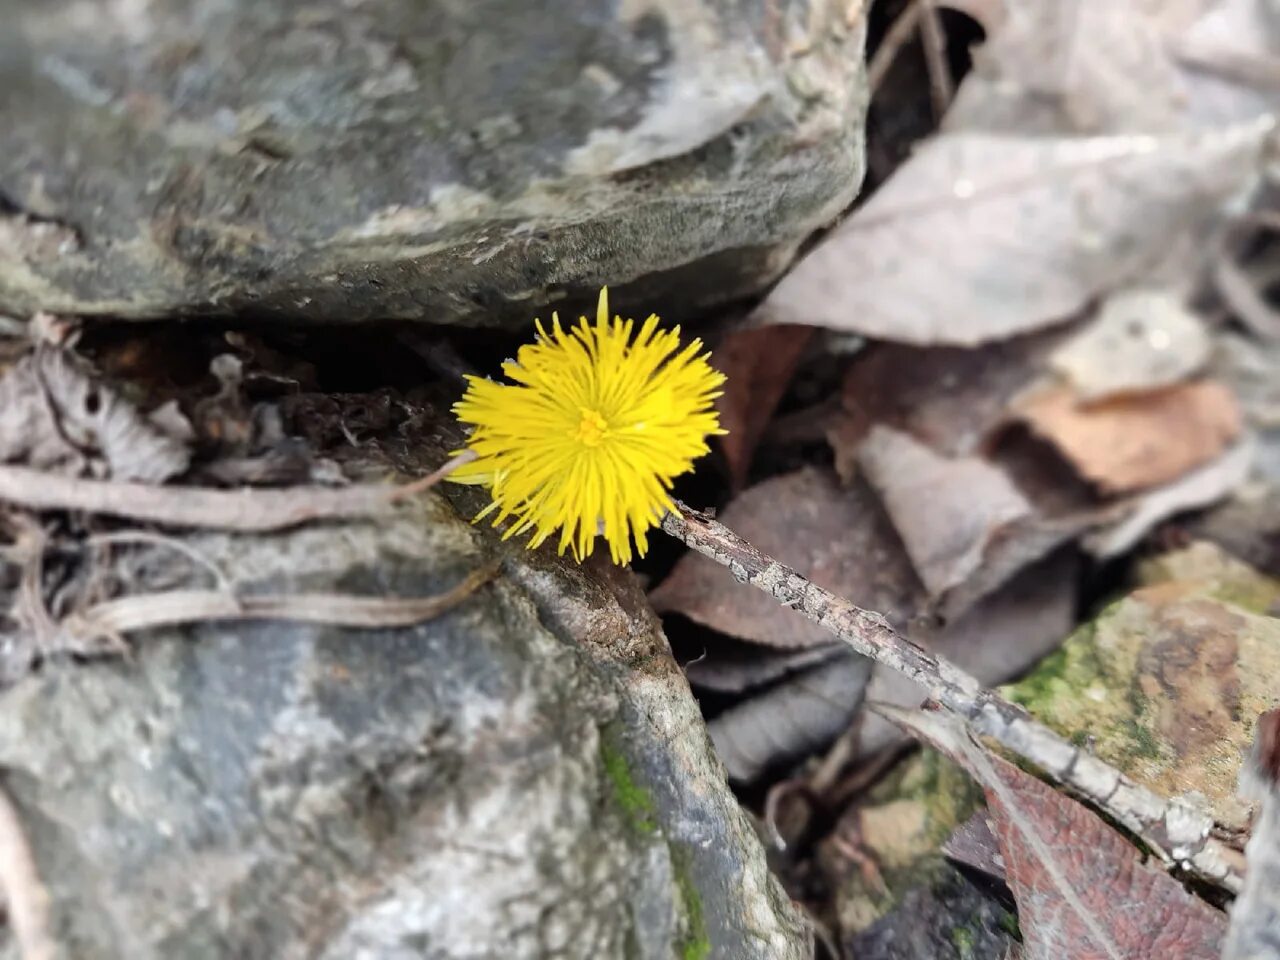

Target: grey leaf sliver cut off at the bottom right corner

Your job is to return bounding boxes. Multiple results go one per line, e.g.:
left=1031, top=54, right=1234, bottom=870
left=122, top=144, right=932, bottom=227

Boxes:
left=1222, top=710, right=1280, bottom=960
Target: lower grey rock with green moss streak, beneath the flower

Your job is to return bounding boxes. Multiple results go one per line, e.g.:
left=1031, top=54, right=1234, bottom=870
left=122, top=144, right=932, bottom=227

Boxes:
left=0, top=495, right=812, bottom=960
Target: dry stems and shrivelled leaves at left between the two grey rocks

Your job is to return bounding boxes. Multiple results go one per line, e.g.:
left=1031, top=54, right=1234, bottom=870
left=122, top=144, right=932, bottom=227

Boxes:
left=0, top=327, right=495, bottom=685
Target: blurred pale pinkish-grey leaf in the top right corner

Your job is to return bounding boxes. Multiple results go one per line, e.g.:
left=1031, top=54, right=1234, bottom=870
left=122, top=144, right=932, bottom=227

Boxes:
left=946, top=0, right=1280, bottom=133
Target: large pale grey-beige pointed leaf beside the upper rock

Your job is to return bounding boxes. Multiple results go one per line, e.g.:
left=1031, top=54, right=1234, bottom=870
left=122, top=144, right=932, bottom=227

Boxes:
left=760, top=118, right=1274, bottom=346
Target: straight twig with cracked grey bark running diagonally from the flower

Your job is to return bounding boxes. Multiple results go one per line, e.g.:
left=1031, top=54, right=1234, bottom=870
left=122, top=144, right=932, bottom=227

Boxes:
left=662, top=502, right=1242, bottom=891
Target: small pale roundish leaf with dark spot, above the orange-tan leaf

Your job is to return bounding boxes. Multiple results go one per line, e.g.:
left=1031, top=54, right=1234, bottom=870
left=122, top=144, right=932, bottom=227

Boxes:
left=1050, top=289, right=1212, bottom=401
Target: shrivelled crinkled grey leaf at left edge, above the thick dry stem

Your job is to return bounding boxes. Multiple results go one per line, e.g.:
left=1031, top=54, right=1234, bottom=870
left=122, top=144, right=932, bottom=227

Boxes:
left=0, top=347, right=192, bottom=484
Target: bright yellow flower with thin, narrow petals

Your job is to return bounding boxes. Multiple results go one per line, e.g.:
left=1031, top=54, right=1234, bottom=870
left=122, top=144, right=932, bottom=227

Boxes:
left=449, top=288, right=724, bottom=563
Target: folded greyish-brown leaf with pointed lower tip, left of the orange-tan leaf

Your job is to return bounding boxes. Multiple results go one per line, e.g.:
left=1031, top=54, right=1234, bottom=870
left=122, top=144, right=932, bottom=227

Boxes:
left=859, top=426, right=1037, bottom=600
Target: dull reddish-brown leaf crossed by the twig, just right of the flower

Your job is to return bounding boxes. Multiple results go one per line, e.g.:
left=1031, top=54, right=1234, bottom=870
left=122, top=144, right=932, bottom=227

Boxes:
left=650, top=468, right=924, bottom=648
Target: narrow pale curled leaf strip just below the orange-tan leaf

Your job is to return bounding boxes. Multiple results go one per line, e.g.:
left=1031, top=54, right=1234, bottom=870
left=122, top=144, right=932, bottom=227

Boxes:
left=1084, top=438, right=1256, bottom=559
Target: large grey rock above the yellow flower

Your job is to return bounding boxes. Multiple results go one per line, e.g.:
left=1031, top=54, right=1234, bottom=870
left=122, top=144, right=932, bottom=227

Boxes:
left=0, top=0, right=867, bottom=324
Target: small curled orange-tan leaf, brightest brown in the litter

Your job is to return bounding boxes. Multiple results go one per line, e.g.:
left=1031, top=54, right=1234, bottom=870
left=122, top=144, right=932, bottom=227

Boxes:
left=1016, top=381, right=1240, bottom=493
